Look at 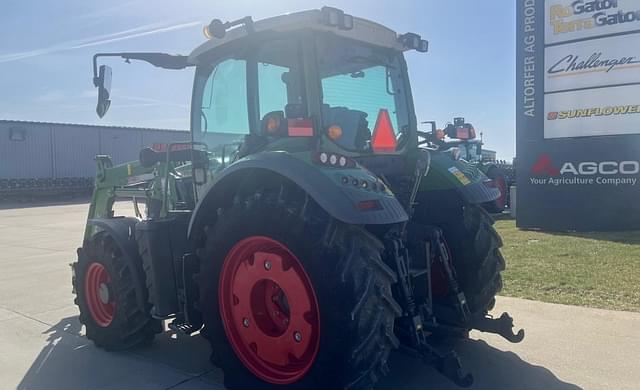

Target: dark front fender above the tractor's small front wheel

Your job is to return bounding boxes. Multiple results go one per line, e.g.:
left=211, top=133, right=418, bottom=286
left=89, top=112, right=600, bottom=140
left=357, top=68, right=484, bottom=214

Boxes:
left=87, top=217, right=147, bottom=307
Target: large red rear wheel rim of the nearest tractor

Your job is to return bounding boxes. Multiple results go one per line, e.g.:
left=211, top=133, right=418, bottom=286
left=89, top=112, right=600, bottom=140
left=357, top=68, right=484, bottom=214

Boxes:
left=219, top=236, right=320, bottom=385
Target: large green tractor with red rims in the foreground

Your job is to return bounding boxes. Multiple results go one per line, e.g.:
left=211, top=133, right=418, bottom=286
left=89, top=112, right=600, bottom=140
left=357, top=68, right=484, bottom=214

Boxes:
left=73, top=7, right=524, bottom=389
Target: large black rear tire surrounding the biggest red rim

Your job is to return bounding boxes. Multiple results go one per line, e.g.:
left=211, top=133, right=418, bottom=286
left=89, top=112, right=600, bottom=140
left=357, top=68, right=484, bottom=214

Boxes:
left=198, top=185, right=400, bottom=390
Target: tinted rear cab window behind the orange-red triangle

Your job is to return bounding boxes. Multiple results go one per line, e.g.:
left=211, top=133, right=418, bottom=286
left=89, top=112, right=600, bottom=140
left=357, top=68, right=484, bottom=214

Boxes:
left=317, top=34, right=409, bottom=151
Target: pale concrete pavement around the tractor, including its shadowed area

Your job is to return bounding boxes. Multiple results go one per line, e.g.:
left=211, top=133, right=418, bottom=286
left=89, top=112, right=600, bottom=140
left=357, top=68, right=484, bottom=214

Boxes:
left=0, top=203, right=640, bottom=390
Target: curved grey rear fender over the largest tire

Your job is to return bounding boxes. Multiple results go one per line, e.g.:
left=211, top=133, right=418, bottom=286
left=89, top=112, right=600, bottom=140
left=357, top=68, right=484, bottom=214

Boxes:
left=188, top=152, right=409, bottom=237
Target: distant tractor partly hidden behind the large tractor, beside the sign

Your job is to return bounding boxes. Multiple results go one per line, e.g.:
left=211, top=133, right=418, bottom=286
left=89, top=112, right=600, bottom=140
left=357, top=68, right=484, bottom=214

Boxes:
left=423, top=118, right=515, bottom=214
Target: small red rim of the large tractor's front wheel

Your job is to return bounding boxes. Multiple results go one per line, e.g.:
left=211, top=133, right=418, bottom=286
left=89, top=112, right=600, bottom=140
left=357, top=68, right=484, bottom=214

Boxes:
left=84, top=263, right=116, bottom=328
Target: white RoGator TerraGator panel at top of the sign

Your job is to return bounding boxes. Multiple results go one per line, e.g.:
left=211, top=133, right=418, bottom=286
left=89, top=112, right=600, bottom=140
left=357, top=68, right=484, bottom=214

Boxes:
left=549, top=0, right=640, bottom=35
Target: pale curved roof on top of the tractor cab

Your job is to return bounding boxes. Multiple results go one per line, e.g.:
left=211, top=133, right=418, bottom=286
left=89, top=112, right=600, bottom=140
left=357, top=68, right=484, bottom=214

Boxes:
left=189, top=7, right=408, bottom=64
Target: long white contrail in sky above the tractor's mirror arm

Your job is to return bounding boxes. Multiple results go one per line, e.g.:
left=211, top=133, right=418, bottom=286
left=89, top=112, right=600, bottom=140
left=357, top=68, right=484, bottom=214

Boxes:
left=0, top=21, right=202, bottom=64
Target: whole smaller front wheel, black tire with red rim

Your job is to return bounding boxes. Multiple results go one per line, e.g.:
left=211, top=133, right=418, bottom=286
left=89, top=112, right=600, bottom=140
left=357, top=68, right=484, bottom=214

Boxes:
left=73, top=232, right=162, bottom=350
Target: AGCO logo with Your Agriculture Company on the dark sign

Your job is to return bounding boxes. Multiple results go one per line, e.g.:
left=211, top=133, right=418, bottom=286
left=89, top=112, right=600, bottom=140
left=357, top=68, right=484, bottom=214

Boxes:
left=530, top=154, right=640, bottom=186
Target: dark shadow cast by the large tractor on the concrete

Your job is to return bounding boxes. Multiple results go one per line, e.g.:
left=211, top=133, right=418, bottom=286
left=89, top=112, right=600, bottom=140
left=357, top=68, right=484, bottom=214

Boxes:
left=17, top=316, right=579, bottom=390
